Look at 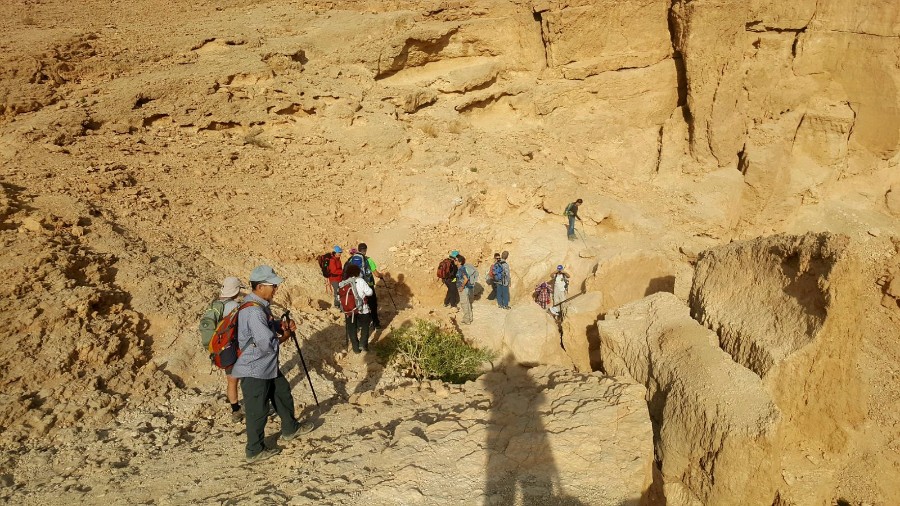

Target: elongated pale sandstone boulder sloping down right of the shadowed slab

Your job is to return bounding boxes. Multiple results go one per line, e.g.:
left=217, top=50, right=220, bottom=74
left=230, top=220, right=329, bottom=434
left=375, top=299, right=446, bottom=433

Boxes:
left=597, top=293, right=780, bottom=504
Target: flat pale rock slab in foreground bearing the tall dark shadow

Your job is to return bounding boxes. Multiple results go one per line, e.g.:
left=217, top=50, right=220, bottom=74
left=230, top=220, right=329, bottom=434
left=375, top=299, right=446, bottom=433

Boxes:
left=351, top=366, right=653, bottom=504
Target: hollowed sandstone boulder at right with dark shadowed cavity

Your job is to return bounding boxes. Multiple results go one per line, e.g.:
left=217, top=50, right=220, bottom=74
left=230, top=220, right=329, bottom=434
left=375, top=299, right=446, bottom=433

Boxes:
left=690, top=233, right=865, bottom=450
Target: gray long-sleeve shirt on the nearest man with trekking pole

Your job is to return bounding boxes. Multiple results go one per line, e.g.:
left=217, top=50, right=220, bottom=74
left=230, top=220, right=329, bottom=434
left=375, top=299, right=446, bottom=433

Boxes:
left=231, top=293, right=281, bottom=379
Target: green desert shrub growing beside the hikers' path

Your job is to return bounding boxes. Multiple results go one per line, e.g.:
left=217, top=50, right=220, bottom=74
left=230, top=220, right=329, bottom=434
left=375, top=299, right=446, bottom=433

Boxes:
left=374, top=320, right=494, bottom=383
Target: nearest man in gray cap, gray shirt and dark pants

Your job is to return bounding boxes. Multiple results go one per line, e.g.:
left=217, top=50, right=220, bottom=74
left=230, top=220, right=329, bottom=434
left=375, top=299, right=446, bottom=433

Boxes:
left=232, top=265, right=314, bottom=463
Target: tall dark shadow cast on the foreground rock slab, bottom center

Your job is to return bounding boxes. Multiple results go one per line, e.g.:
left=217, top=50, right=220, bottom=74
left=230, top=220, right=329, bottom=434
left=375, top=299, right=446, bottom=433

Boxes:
left=484, top=356, right=585, bottom=505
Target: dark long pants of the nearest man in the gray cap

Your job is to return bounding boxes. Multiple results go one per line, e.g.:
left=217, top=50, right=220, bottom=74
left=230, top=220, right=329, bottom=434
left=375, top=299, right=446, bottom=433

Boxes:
left=241, top=370, right=300, bottom=457
